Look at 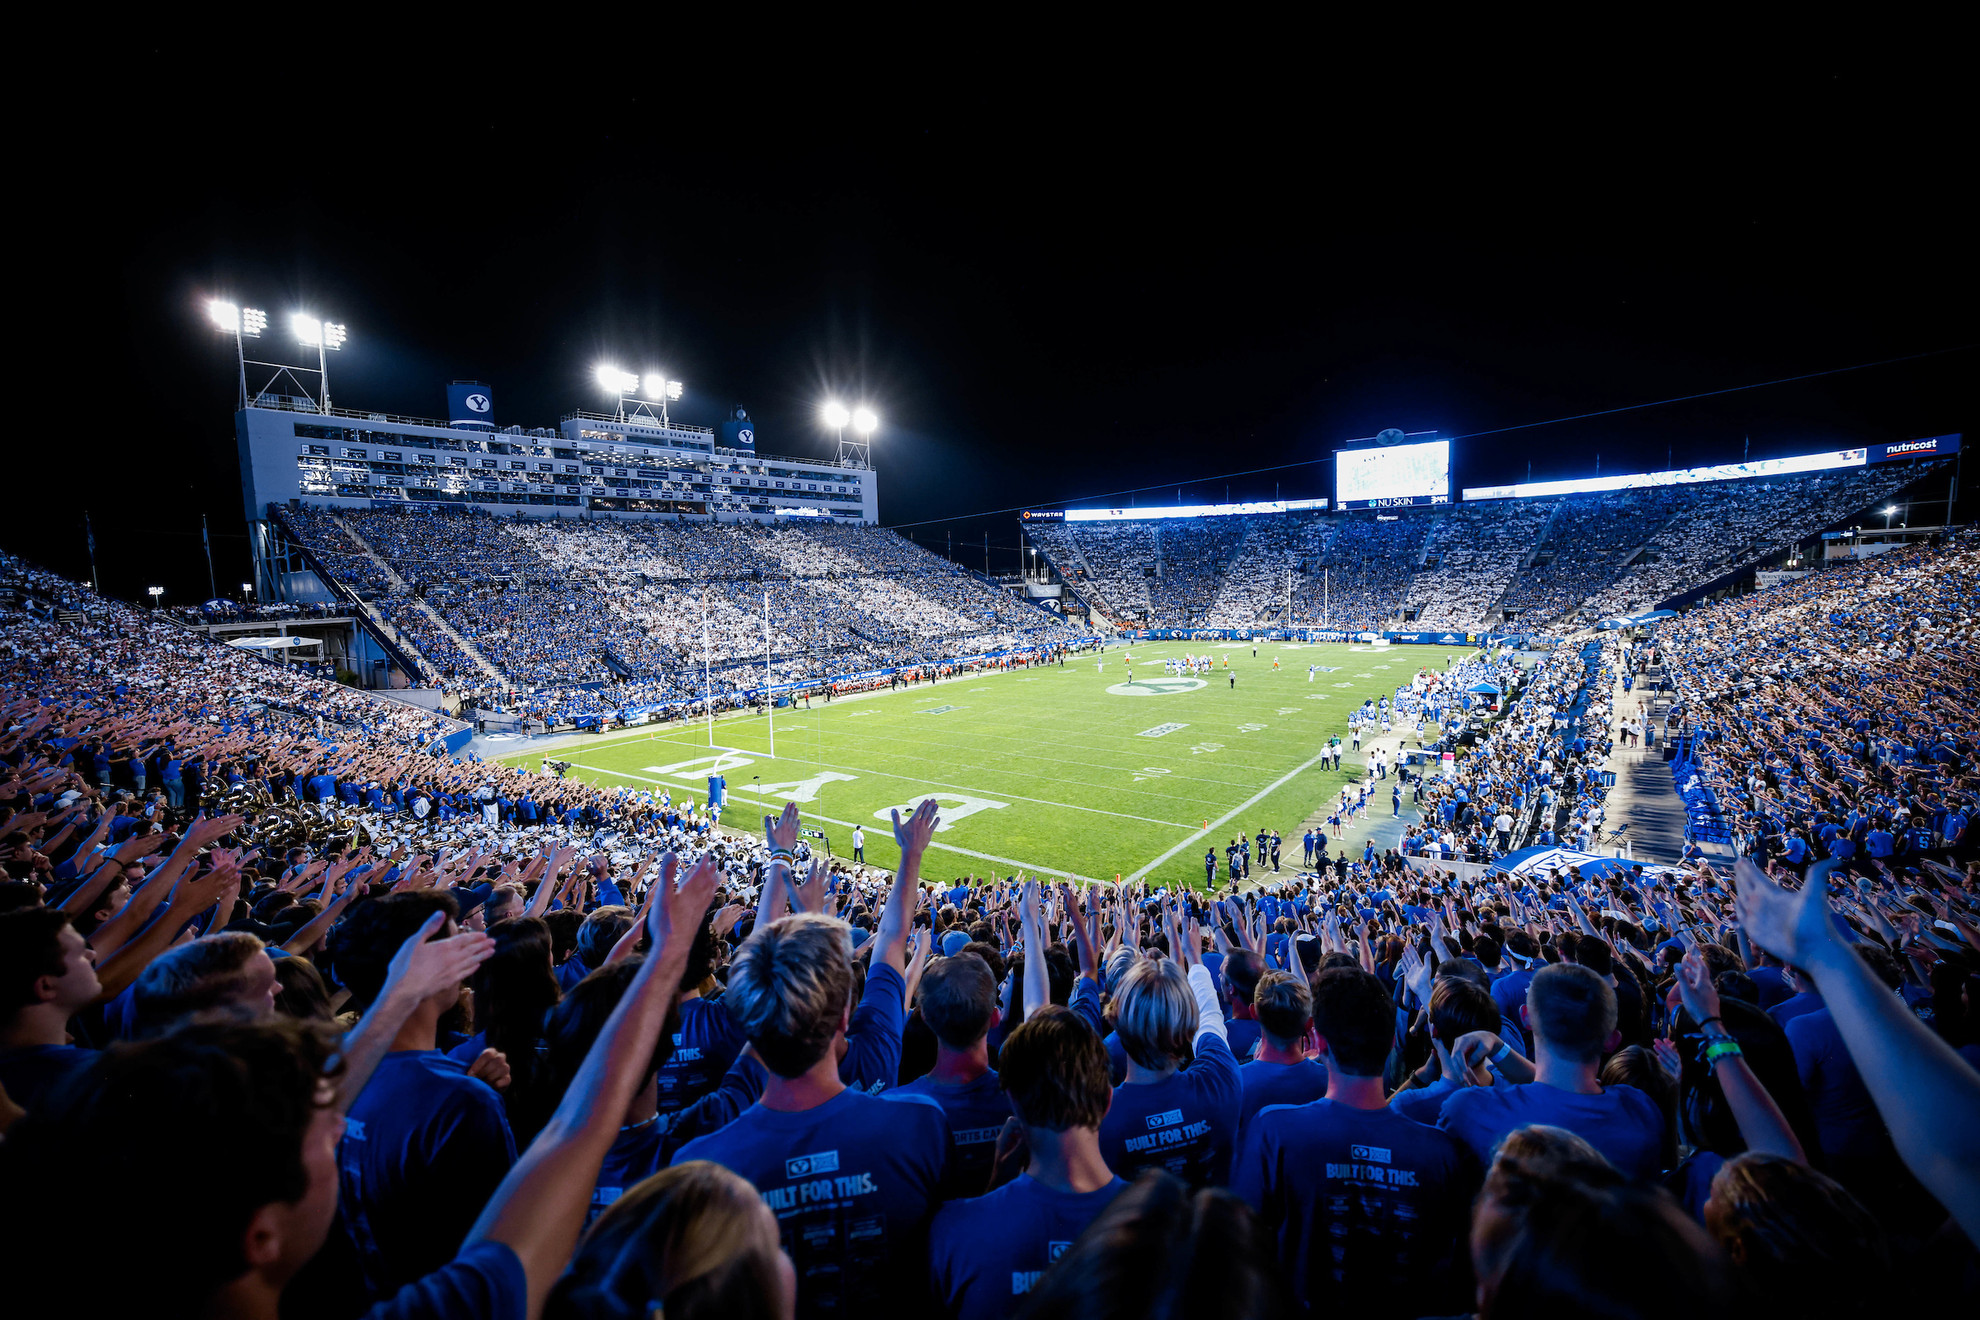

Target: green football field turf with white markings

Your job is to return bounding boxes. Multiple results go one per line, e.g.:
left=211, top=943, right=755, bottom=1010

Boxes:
left=503, top=641, right=1473, bottom=885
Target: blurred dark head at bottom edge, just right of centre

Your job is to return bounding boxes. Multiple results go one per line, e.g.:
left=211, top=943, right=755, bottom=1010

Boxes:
left=1018, top=1170, right=1293, bottom=1320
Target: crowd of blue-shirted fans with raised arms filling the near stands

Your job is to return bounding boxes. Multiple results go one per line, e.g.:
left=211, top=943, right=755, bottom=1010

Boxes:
left=0, top=538, right=1980, bottom=1320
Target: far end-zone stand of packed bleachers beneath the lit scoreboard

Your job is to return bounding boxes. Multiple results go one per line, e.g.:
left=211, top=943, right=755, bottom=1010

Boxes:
left=1030, top=465, right=1931, bottom=629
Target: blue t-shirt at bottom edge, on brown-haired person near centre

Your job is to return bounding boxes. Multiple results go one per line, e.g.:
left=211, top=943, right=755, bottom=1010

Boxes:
left=929, top=1174, right=1127, bottom=1320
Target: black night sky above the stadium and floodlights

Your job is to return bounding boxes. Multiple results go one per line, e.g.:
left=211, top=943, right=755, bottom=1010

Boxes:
left=27, top=42, right=1980, bottom=602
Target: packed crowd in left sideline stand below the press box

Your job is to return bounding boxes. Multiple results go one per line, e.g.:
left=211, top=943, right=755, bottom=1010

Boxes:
left=281, top=507, right=1077, bottom=720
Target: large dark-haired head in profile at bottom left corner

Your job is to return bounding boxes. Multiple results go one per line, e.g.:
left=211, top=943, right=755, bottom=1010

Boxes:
left=0, top=1019, right=339, bottom=1318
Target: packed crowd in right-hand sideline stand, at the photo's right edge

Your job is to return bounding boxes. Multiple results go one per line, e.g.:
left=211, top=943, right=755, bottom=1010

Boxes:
left=1657, top=534, right=1980, bottom=869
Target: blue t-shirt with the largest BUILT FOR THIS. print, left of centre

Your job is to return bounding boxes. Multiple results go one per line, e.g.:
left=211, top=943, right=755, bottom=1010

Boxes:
left=673, top=1086, right=948, bottom=1316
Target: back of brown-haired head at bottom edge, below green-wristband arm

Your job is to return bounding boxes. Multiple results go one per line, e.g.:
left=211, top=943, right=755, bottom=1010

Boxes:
left=1705, top=1152, right=1891, bottom=1316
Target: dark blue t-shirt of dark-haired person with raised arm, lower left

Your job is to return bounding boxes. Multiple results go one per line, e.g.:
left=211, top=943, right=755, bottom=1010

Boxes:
left=337, top=1049, right=515, bottom=1300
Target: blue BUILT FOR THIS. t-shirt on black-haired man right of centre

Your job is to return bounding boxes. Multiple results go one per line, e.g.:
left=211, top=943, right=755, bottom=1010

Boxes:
left=1232, top=1100, right=1479, bottom=1318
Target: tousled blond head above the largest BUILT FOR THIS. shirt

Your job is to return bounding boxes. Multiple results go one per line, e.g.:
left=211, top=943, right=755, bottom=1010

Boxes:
left=723, top=912, right=853, bottom=1079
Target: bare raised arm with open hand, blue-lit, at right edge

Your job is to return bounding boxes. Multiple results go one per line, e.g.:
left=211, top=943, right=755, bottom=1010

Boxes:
left=1729, top=859, right=1980, bottom=1241
